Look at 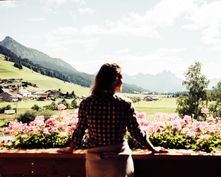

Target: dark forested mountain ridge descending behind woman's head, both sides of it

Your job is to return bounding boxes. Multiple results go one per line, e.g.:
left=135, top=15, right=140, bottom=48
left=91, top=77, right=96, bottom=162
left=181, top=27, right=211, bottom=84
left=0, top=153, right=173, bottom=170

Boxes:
left=0, top=36, right=146, bottom=93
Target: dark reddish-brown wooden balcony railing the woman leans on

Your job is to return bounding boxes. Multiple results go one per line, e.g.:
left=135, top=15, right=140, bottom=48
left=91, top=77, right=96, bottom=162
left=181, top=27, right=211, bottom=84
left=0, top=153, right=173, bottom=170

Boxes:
left=0, top=149, right=221, bottom=177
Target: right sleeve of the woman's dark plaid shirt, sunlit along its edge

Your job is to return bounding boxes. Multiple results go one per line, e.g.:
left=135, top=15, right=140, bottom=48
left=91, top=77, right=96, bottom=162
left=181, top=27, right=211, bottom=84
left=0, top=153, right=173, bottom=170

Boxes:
left=127, top=103, right=153, bottom=150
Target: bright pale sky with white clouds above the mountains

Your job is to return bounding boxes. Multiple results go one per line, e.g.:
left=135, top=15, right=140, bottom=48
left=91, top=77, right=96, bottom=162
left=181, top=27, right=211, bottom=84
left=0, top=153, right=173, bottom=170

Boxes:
left=0, top=0, right=221, bottom=79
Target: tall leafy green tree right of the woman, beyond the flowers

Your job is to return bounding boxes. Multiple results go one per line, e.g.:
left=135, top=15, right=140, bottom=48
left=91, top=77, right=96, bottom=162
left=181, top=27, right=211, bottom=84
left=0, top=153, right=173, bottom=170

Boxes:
left=177, top=62, right=209, bottom=119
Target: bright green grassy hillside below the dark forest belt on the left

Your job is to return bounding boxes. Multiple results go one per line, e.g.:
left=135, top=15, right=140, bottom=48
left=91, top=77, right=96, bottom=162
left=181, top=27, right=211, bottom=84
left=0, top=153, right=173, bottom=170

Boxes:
left=0, top=53, right=89, bottom=96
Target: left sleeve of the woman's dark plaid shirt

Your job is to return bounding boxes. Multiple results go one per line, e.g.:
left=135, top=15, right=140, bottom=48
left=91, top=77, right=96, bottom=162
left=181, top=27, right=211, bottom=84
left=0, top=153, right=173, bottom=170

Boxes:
left=71, top=101, right=87, bottom=147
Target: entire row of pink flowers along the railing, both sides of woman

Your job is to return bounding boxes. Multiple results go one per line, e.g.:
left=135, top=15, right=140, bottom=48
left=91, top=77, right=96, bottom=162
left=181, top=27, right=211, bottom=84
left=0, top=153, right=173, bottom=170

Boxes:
left=1, top=110, right=221, bottom=152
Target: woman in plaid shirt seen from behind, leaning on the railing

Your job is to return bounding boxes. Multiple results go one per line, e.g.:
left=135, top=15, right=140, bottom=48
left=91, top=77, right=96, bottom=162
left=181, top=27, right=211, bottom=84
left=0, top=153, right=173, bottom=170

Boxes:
left=59, top=63, right=166, bottom=177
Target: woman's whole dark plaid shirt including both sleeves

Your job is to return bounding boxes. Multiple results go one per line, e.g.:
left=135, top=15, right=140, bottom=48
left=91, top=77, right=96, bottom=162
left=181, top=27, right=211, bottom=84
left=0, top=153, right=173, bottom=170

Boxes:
left=72, top=92, right=150, bottom=148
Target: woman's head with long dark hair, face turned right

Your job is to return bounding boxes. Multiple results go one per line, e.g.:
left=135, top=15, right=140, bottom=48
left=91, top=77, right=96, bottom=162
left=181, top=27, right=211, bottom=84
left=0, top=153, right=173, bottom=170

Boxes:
left=91, top=63, right=122, bottom=95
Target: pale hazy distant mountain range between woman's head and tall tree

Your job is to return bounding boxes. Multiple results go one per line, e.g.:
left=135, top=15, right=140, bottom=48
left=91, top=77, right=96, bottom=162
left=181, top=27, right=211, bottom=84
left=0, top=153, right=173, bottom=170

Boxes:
left=124, top=71, right=185, bottom=93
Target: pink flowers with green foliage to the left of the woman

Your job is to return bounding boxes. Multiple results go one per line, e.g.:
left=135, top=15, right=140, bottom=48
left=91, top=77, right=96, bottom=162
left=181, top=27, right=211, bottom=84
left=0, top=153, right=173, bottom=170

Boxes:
left=3, top=110, right=78, bottom=148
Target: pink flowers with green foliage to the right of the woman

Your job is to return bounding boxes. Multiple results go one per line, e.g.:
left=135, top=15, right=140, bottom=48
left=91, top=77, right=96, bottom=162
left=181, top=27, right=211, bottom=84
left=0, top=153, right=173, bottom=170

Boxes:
left=135, top=114, right=221, bottom=152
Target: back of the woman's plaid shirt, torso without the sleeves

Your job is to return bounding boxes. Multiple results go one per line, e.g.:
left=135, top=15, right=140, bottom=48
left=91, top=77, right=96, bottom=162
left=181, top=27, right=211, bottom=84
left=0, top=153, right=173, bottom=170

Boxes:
left=81, top=92, right=130, bottom=147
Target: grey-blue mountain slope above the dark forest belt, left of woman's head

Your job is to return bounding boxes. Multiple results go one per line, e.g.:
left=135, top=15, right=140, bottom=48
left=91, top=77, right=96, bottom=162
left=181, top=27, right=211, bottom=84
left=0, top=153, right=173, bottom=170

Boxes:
left=0, top=36, right=94, bottom=87
